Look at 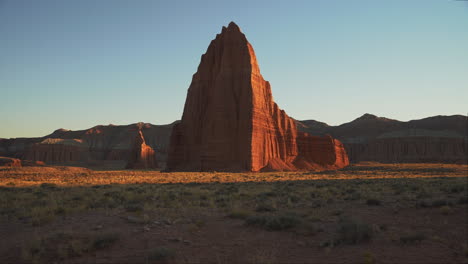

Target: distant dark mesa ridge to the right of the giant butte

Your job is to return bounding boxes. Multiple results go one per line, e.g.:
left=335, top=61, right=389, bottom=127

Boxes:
left=297, top=114, right=468, bottom=164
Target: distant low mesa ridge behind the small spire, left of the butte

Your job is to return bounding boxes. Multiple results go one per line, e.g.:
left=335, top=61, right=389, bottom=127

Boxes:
left=0, top=123, right=173, bottom=169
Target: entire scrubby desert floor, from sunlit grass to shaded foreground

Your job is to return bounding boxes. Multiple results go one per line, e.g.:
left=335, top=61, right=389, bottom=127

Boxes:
left=0, top=163, right=468, bottom=263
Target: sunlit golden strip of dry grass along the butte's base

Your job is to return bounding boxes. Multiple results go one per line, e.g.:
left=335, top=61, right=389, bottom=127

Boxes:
left=0, top=163, right=468, bottom=187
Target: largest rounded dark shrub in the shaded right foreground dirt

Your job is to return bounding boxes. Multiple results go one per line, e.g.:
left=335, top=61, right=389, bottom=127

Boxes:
left=335, top=219, right=373, bottom=244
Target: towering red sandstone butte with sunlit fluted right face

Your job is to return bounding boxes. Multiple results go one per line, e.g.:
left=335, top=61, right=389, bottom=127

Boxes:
left=167, top=22, right=349, bottom=172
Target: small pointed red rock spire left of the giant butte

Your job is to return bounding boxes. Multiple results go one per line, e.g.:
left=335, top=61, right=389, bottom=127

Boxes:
left=126, top=130, right=158, bottom=169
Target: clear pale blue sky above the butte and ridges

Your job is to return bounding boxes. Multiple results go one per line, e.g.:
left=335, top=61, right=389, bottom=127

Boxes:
left=0, top=0, right=468, bottom=138
